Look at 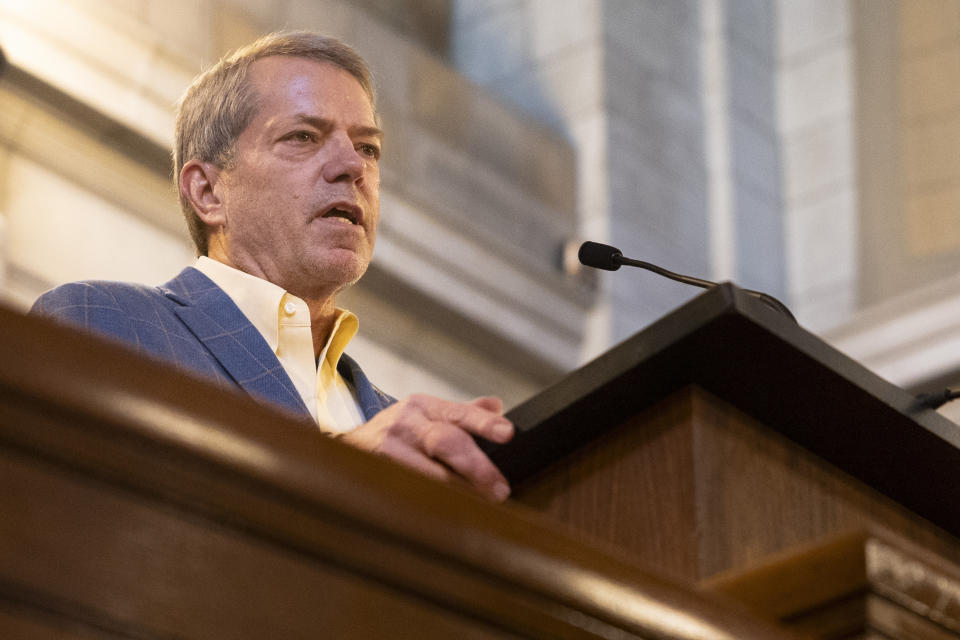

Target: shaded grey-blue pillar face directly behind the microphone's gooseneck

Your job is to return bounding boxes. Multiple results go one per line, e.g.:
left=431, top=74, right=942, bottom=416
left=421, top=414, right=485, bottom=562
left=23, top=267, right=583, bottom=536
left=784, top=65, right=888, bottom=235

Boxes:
left=602, top=0, right=710, bottom=341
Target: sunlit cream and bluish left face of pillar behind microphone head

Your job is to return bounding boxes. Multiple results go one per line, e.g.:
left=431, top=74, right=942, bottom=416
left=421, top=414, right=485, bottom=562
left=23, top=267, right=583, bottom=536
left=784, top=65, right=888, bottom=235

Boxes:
left=450, top=0, right=611, bottom=359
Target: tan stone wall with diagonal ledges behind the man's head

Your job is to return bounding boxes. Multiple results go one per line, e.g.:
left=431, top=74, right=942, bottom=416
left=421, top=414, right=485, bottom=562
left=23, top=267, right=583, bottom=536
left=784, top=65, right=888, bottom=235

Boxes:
left=0, top=0, right=593, bottom=404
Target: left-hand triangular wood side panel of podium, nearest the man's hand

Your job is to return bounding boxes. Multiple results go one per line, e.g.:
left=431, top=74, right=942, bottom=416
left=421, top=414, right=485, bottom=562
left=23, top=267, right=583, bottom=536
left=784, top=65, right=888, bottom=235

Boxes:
left=514, top=388, right=699, bottom=580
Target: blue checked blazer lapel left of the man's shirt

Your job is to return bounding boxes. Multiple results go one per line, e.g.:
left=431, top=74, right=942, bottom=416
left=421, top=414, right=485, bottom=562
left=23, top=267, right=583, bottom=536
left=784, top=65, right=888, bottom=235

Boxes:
left=161, top=267, right=310, bottom=416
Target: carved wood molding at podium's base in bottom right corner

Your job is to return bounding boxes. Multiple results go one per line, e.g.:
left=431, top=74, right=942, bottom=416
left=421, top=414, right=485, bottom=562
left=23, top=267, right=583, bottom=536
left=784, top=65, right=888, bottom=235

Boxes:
left=703, top=530, right=960, bottom=640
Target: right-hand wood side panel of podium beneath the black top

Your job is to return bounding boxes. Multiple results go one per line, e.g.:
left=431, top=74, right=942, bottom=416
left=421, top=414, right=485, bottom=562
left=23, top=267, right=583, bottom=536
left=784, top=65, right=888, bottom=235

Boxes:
left=691, top=392, right=960, bottom=578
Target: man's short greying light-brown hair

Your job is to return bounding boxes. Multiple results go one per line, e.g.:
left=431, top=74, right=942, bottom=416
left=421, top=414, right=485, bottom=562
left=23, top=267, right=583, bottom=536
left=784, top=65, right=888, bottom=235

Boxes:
left=173, top=31, right=376, bottom=255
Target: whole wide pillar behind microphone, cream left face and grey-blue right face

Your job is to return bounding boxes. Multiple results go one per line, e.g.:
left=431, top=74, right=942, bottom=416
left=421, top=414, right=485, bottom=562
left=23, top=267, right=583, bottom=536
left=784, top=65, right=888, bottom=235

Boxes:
left=451, top=0, right=710, bottom=357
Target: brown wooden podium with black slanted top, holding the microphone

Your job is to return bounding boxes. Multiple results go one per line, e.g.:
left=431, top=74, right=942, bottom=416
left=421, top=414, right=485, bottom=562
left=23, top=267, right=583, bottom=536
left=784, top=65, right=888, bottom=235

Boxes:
left=491, top=284, right=960, bottom=638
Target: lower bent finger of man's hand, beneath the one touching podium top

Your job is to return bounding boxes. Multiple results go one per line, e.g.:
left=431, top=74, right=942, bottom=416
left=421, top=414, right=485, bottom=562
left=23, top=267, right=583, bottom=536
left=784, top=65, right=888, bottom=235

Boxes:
left=422, top=422, right=510, bottom=502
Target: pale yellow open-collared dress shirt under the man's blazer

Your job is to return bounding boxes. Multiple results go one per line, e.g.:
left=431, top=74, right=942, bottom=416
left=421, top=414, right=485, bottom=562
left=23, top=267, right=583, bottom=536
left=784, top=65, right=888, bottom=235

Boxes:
left=194, top=256, right=364, bottom=433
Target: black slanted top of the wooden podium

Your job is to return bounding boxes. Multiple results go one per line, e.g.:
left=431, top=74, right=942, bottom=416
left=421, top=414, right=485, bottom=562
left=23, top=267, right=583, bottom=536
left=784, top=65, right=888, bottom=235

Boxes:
left=489, top=283, right=960, bottom=537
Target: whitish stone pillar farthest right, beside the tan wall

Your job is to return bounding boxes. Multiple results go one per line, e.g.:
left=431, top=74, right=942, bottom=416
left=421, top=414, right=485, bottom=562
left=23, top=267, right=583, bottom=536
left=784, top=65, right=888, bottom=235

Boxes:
left=776, top=0, right=858, bottom=331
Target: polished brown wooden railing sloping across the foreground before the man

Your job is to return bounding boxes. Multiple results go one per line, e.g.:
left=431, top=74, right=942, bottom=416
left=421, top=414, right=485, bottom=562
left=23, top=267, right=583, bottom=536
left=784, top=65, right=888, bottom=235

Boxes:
left=0, top=309, right=791, bottom=640
